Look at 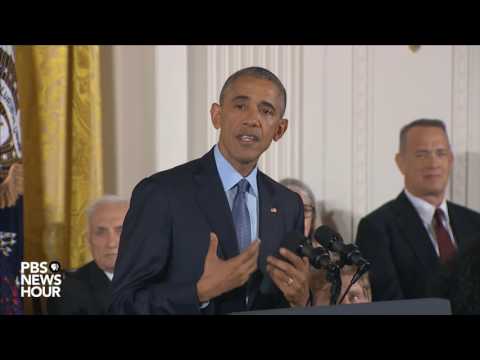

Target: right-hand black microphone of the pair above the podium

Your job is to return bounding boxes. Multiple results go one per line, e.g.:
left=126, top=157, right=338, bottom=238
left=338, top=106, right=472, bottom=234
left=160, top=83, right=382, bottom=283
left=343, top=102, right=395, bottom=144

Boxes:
left=314, top=225, right=370, bottom=283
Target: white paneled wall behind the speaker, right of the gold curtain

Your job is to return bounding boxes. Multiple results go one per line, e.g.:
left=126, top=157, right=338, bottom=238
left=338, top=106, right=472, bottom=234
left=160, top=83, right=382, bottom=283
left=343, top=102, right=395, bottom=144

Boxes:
left=103, top=46, right=480, bottom=240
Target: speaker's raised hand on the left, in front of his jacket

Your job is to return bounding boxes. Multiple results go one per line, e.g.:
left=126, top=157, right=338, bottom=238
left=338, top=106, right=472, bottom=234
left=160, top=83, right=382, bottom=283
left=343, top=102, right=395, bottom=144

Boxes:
left=197, top=233, right=260, bottom=303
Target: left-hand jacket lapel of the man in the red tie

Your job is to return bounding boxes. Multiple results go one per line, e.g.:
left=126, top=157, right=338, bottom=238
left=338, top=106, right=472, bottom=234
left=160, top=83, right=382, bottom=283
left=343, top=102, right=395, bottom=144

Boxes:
left=394, top=192, right=438, bottom=269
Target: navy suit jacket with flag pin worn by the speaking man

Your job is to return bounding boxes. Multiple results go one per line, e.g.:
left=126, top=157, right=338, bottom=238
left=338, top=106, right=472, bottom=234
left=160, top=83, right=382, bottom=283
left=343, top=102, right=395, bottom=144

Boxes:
left=110, top=149, right=304, bottom=314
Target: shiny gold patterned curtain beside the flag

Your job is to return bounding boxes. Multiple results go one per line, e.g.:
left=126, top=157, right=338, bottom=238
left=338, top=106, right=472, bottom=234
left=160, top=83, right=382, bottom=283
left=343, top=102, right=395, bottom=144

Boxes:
left=16, top=46, right=103, bottom=269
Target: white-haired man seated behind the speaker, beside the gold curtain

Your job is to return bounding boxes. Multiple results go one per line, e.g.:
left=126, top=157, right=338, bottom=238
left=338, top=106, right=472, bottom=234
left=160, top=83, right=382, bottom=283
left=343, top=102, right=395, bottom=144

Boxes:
left=47, top=195, right=128, bottom=315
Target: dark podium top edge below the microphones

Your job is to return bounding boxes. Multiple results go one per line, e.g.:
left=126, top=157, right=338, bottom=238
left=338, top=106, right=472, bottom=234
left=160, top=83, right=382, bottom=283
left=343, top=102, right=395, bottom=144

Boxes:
left=230, top=298, right=452, bottom=315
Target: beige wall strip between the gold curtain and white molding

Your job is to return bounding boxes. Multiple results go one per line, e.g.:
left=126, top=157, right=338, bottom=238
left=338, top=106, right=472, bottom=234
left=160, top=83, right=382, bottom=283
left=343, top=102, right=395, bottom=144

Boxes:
left=101, top=46, right=158, bottom=196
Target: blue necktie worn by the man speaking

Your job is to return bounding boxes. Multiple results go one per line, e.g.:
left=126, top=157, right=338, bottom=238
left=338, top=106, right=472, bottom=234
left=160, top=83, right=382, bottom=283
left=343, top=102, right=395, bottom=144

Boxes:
left=232, top=179, right=252, bottom=252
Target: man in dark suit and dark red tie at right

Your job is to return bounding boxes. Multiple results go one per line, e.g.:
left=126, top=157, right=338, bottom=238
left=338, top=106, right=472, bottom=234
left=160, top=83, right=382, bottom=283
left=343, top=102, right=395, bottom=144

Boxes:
left=356, top=119, right=480, bottom=300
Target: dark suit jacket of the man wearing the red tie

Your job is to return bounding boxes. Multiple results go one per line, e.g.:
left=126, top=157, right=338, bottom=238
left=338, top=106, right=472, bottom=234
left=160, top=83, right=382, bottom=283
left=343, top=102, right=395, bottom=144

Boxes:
left=356, top=192, right=480, bottom=301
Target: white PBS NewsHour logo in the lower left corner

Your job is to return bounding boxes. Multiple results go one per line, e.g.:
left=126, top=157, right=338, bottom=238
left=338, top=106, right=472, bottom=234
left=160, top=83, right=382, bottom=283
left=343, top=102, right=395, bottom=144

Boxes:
left=20, top=261, right=63, bottom=298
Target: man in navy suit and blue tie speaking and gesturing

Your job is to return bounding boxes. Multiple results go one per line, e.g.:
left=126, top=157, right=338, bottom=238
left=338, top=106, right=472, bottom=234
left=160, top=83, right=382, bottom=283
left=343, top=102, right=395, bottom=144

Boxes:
left=110, top=67, right=310, bottom=314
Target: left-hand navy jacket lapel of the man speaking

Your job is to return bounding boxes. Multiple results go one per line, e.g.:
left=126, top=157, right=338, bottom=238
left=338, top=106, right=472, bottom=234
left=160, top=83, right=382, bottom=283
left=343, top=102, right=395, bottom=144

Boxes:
left=194, top=148, right=239, bottom=259
